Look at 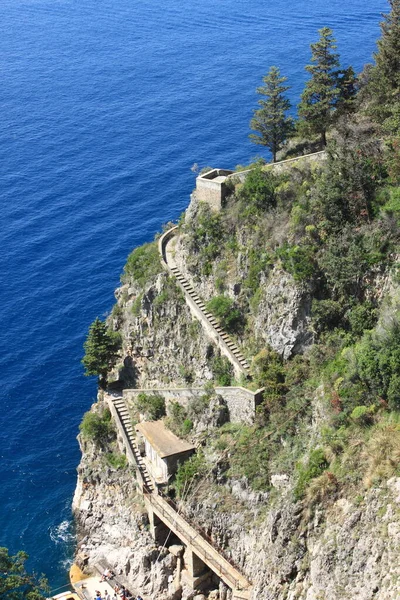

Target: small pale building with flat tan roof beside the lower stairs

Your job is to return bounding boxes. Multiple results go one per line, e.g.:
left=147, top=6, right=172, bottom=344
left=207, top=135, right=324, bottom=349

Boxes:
left=135, top=421, right=196, bottom=485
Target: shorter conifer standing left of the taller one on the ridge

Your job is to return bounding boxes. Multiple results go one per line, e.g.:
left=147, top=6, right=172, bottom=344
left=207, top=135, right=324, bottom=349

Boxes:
left=250, top=67, right=294, bottom=162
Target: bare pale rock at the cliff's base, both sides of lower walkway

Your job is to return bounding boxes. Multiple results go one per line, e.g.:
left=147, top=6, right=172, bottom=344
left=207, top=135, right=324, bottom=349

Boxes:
left=74, top=412, right=400, bottom=600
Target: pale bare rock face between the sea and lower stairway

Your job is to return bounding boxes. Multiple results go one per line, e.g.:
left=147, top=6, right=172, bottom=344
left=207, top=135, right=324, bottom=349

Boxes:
left=73, top=406, right=180, bottom=598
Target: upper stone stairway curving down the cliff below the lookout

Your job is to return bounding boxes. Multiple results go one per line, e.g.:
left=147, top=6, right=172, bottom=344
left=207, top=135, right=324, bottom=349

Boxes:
left=158, top=227, right=250, bottom=377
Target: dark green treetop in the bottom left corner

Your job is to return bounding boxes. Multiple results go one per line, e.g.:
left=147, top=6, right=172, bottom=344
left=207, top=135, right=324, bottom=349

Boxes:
left=0, top=548, right=49, bottom=600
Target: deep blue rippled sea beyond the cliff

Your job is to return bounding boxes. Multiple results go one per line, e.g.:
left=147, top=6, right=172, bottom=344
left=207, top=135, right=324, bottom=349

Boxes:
left=0, top=0, right=387, bottom=590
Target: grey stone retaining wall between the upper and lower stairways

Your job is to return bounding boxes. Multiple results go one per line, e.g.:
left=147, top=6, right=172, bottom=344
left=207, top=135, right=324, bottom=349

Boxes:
left=123, top=386, right=264, bottom=424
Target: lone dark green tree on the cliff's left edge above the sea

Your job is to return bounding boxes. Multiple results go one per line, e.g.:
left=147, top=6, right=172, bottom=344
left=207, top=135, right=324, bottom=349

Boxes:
left=82, top=318, right=120, bottom=384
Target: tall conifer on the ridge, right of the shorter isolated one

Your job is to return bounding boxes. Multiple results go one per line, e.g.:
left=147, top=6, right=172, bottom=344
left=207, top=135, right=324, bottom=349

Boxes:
left=298, top=27, right=340, bottom=146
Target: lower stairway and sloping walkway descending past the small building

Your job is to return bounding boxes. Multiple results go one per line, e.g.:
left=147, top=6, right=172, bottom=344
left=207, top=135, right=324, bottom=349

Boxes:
left=106, top=395, right=252, bottom=600
